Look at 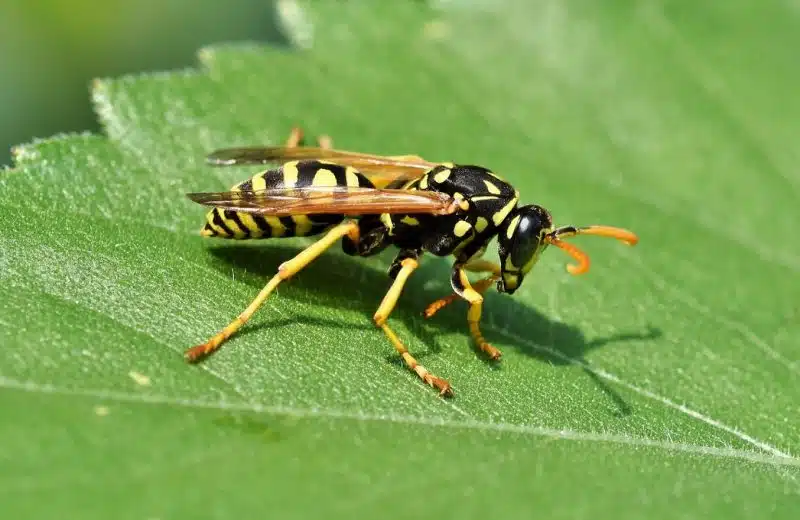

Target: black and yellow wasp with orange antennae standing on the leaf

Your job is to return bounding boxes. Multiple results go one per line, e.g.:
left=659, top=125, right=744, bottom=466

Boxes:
left=185, top=128, right=638, bottom=396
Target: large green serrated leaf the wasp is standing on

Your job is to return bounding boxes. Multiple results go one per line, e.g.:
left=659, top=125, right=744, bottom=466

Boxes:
left=0, top=0, right=800, bottom=519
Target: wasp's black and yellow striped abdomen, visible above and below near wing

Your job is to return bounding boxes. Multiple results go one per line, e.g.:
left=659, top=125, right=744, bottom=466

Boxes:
left=200, top=161, right=372, bottom=239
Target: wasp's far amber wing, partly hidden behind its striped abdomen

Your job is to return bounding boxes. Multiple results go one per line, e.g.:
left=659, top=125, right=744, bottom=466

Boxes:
left=207, top=146, right=436, bottom=188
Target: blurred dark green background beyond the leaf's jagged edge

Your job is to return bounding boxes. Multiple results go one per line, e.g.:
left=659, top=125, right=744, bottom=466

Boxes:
left=0, top=0, right=286, bottom=165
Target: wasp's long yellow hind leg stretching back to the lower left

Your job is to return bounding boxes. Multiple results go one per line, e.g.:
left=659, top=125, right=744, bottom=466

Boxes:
left=184, top=221, right=358, bottom=362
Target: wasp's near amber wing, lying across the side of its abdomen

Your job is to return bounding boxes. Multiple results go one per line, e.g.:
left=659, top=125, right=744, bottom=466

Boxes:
left=187, top=186, right=458, bottom=216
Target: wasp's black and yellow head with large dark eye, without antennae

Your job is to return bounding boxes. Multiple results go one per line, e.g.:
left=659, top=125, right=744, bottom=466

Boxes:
left=497, top=204, right=553, bottom=294
